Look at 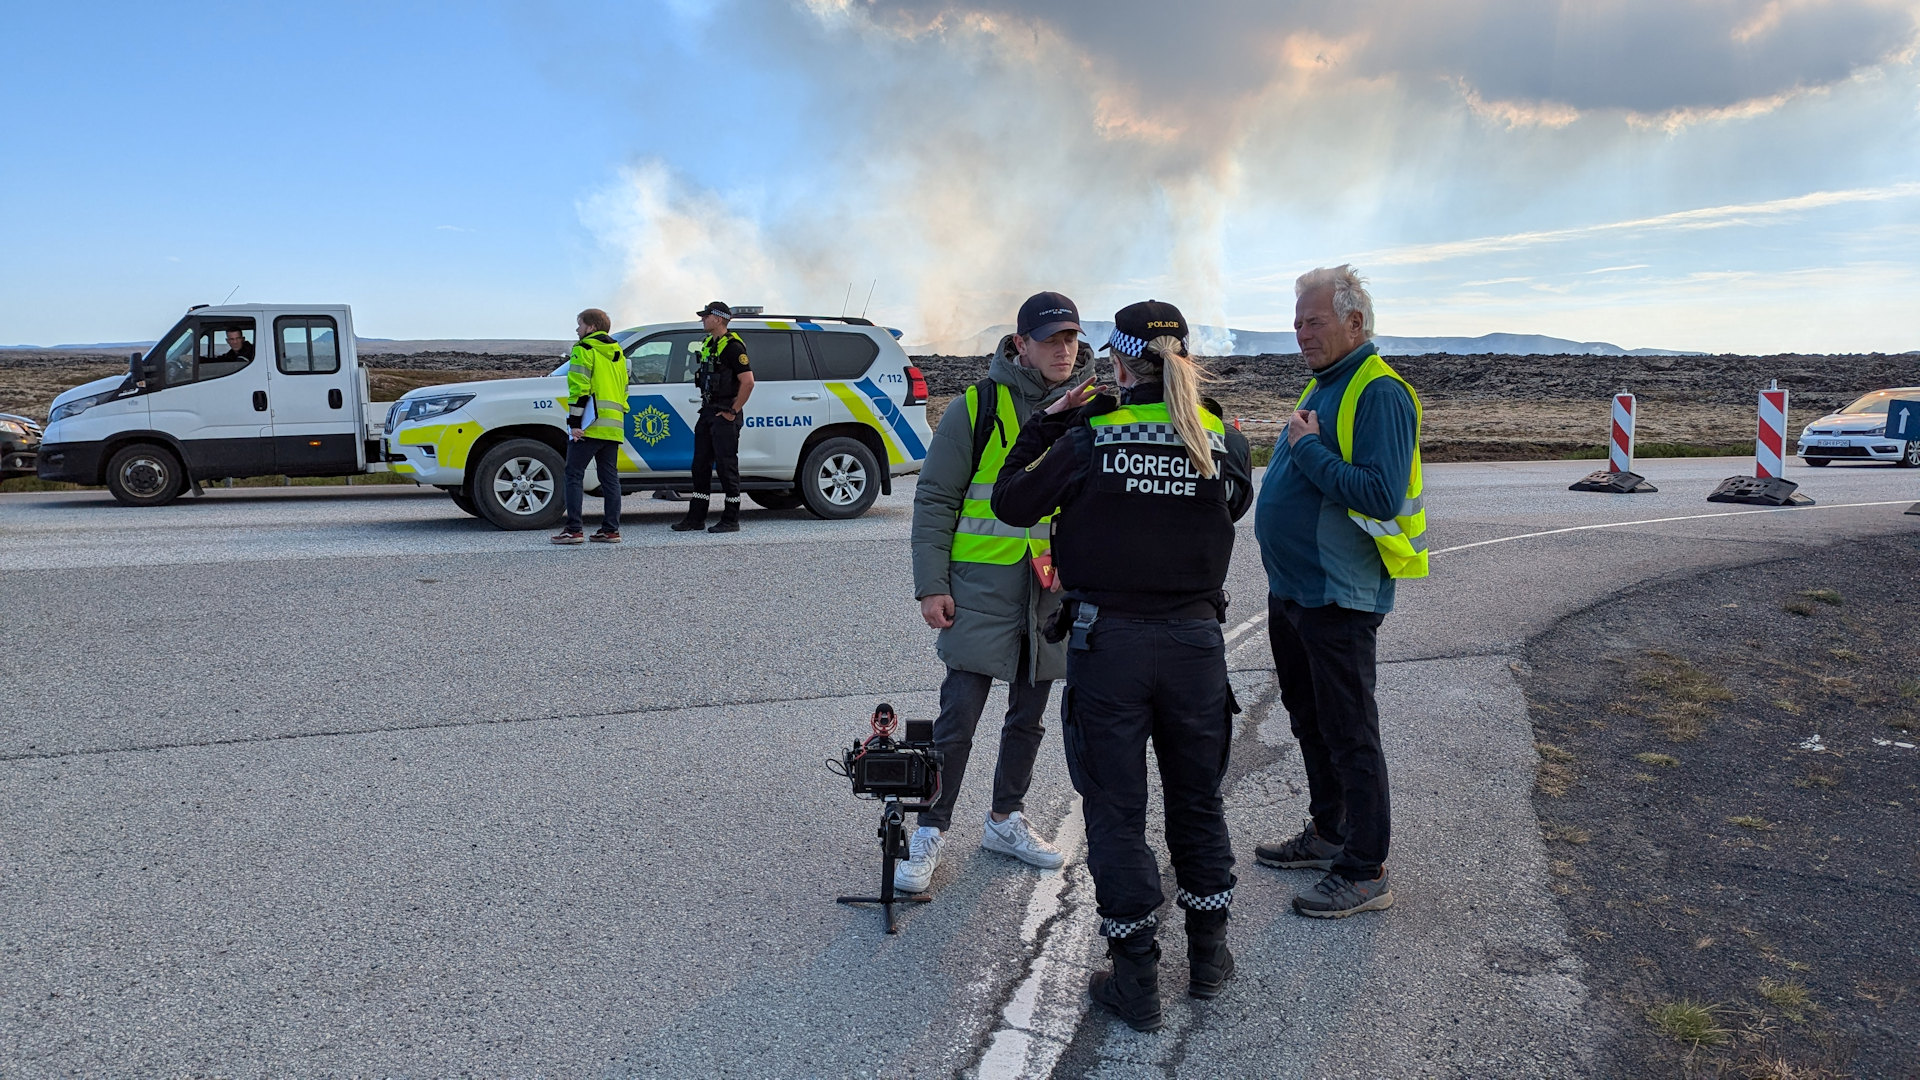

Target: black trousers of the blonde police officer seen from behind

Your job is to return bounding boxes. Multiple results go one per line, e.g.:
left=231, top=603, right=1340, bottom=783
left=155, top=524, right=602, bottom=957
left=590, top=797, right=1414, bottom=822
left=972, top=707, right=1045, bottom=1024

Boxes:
left=1060, top=617, right=1235, bottom=938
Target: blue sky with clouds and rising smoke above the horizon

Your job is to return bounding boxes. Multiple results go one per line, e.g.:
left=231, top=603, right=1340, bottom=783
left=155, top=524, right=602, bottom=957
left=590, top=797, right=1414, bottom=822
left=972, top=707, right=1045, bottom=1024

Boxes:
left=0, top=0, right=1920, bottom=352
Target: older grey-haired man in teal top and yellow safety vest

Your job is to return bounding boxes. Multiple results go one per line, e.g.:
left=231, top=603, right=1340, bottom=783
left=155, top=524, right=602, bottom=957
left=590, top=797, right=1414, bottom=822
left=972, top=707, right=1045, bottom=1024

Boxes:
left=1254, top=265, right=1427, bottom=919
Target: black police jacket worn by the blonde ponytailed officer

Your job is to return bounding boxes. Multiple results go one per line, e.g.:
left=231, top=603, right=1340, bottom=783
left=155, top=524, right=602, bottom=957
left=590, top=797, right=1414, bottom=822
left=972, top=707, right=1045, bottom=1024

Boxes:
left=993, top=382, right=1254, bottom=619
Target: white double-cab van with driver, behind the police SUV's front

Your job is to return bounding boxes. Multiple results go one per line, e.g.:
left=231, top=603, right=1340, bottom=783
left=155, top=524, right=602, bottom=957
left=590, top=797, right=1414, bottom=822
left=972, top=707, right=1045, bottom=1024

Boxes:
left=36, top=304, right=384, bottom=505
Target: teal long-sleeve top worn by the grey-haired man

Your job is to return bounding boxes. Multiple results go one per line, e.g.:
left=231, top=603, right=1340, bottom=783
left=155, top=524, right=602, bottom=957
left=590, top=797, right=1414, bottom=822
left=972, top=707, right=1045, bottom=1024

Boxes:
left=1254, top=342, right=1419, bottom=613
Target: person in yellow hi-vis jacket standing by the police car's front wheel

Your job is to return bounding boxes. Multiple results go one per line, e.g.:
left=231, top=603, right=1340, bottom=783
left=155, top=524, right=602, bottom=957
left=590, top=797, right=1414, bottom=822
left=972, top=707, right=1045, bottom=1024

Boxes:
left=553, top=307, right=628, bottom=544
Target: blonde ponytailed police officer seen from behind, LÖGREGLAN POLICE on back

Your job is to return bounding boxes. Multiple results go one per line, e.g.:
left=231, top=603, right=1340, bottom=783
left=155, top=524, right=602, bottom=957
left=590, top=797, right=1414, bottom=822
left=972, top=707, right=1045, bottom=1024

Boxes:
left=993, top=300, right=1252, bottom=1030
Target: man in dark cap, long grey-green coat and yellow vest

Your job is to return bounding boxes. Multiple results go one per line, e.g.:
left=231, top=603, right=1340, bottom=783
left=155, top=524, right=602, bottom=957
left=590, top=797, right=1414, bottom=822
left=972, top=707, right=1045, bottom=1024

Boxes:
left=893, top=292, right=1092, bottom=892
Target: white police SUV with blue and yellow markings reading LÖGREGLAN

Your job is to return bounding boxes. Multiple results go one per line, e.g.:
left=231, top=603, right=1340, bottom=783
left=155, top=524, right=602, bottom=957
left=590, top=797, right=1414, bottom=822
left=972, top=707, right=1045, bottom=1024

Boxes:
left=386, top=307, right=933, bottom=528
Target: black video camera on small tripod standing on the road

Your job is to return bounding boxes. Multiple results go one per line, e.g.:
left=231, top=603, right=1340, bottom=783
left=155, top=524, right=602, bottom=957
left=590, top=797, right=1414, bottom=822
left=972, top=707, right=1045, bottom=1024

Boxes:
left=828, top=705, right=945, bottom=934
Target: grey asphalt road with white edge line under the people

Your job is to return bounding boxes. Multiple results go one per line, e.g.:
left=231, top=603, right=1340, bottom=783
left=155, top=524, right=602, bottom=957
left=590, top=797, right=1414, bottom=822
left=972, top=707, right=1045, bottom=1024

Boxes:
left=0, top=459, right=1920, bottom=1076
